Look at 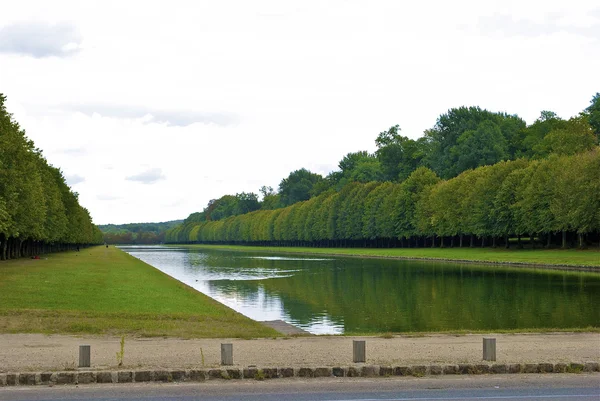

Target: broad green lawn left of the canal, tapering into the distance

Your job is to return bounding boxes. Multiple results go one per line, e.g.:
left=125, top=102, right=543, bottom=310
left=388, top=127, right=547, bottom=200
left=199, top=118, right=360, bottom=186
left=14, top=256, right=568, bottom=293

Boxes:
left=0, top=247, right=277, bottom=338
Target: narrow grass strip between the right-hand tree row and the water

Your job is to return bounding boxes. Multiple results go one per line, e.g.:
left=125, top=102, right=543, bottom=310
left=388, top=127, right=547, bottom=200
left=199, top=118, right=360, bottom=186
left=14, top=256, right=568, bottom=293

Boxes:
left=173, top=245, right=600, bottom=270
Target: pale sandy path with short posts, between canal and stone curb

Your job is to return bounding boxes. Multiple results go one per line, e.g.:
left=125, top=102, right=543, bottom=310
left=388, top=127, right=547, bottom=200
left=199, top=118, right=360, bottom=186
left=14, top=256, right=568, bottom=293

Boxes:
left=0, top=333, right=600, bottom=372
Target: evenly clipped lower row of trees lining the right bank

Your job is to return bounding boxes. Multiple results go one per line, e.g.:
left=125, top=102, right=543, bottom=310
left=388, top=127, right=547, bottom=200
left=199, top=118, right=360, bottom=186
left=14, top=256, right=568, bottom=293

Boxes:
left=166, top=146, right=600, bottom=247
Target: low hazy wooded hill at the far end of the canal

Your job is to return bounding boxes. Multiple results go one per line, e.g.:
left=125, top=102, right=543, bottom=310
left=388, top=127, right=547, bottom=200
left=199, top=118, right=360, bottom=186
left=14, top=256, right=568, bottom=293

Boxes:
left=98, top=220, right=183, bottom=245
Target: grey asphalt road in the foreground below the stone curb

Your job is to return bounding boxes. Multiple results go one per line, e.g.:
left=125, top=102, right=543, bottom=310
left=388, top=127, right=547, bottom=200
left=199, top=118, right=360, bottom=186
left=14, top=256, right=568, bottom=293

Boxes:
left=0, top=374, right=600, bottom=401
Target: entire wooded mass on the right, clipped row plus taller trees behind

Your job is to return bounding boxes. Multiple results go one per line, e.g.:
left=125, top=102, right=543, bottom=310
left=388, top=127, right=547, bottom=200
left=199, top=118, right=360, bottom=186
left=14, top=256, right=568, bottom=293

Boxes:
left=166, top=93, right=600, bottom=247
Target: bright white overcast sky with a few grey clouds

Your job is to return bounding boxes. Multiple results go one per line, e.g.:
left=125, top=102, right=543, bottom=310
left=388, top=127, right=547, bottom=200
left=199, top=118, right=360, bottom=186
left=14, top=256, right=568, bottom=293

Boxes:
left=0, top=0, right=600, bottom=224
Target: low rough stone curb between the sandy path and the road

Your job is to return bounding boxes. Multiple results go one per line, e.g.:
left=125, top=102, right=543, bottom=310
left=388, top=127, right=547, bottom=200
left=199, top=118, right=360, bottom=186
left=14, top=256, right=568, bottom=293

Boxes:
left=0, top=362, right=600, bottom=387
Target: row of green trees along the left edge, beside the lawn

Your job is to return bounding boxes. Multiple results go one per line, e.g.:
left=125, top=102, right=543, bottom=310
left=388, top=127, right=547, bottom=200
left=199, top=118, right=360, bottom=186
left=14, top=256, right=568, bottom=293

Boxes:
left=0, top=94, right=102, bottom=260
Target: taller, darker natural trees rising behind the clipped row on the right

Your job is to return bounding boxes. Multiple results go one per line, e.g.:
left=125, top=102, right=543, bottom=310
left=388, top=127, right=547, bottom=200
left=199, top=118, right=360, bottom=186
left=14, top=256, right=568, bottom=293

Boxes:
left=184, top=93, right=600, bottom=224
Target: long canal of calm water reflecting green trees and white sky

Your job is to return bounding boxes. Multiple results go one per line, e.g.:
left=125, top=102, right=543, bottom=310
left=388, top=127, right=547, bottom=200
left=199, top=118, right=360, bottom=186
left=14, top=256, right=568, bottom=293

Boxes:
left=122, top=246, right=600, bottom=334
